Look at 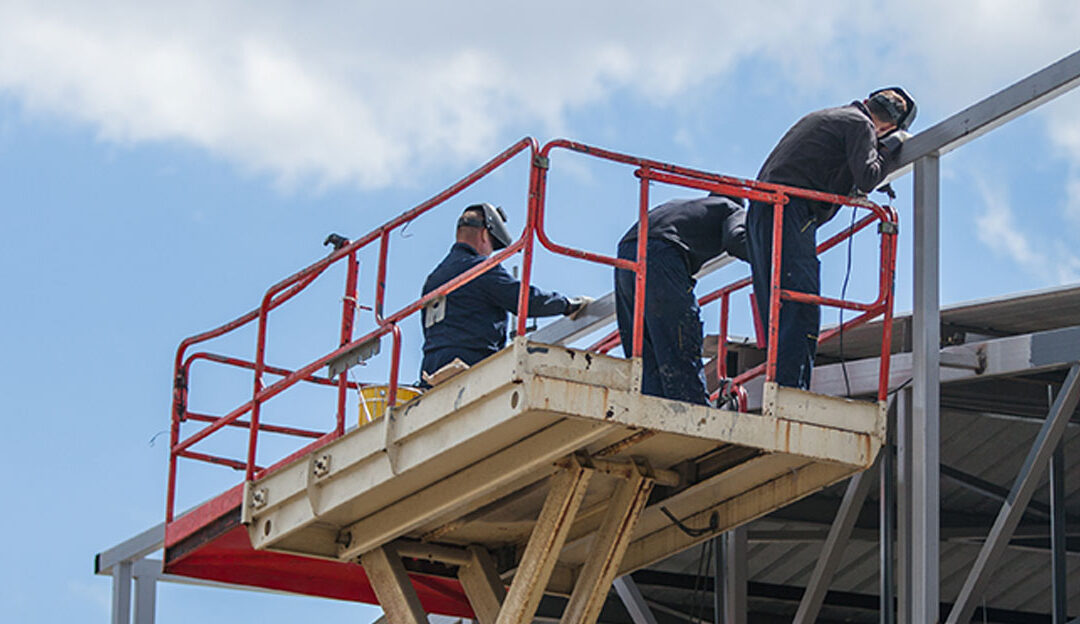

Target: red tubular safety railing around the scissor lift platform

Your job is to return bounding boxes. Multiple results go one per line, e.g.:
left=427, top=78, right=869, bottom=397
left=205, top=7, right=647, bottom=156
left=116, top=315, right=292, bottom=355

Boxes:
left=166, top=137, right=896, bottom=521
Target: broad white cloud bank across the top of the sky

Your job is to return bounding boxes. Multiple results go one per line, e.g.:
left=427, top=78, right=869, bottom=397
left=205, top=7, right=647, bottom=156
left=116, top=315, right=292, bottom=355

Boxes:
left=0, top=0, right=1080, bottom=188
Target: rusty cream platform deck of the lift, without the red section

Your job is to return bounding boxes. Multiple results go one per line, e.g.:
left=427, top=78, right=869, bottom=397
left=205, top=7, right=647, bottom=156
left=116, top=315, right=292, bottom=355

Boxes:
left=242, top=339, right=885, bottom=593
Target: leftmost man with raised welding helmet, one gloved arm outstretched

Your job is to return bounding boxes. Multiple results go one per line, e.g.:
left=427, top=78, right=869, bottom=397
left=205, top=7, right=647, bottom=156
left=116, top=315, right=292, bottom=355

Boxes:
left=420, top=203, right=592, bottom=385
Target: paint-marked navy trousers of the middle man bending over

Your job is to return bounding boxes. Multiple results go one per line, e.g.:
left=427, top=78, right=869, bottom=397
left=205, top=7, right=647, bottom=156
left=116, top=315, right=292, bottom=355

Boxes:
left=615, top=240, right=708, bottom=405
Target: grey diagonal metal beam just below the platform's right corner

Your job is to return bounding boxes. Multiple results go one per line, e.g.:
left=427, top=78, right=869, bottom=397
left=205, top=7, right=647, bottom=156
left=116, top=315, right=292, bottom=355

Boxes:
left=792, top=462, right=875, bottom=624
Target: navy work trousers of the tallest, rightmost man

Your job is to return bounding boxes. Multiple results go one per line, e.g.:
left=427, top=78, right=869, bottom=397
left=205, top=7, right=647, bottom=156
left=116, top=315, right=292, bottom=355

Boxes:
left=746, top=198, right=821, bottom=390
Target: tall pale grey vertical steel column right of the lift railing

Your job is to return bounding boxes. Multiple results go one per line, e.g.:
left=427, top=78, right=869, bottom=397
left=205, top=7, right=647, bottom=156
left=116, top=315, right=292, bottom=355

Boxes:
left=902, top=153, right=941, bottom=623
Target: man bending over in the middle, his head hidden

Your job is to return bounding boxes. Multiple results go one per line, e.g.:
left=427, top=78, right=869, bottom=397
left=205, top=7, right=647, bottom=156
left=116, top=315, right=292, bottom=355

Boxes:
left=615, top=194, right=746, bottom=405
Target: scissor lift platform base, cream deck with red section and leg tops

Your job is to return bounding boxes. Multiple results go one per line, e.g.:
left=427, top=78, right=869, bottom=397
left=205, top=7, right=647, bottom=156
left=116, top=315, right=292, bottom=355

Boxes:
left=165, top=338, right=885, bottom=623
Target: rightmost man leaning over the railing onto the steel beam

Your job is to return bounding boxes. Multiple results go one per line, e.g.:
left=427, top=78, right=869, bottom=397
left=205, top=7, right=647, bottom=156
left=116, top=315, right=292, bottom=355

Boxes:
left=746, top=86, right=916, bottom=390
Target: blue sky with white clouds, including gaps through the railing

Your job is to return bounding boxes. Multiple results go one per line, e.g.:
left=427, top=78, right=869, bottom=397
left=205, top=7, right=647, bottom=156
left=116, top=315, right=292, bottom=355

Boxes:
left=0, top=0, right=1080, bottom=624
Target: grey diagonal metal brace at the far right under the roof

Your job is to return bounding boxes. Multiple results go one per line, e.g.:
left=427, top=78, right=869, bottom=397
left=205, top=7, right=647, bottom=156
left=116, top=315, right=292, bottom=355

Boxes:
left=946, top=364, right=1080, bottom=624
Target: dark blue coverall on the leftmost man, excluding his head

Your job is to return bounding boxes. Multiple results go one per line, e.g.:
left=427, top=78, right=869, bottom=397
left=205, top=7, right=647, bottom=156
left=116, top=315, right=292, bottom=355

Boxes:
left=420, top=243, right=569, bottom=379
